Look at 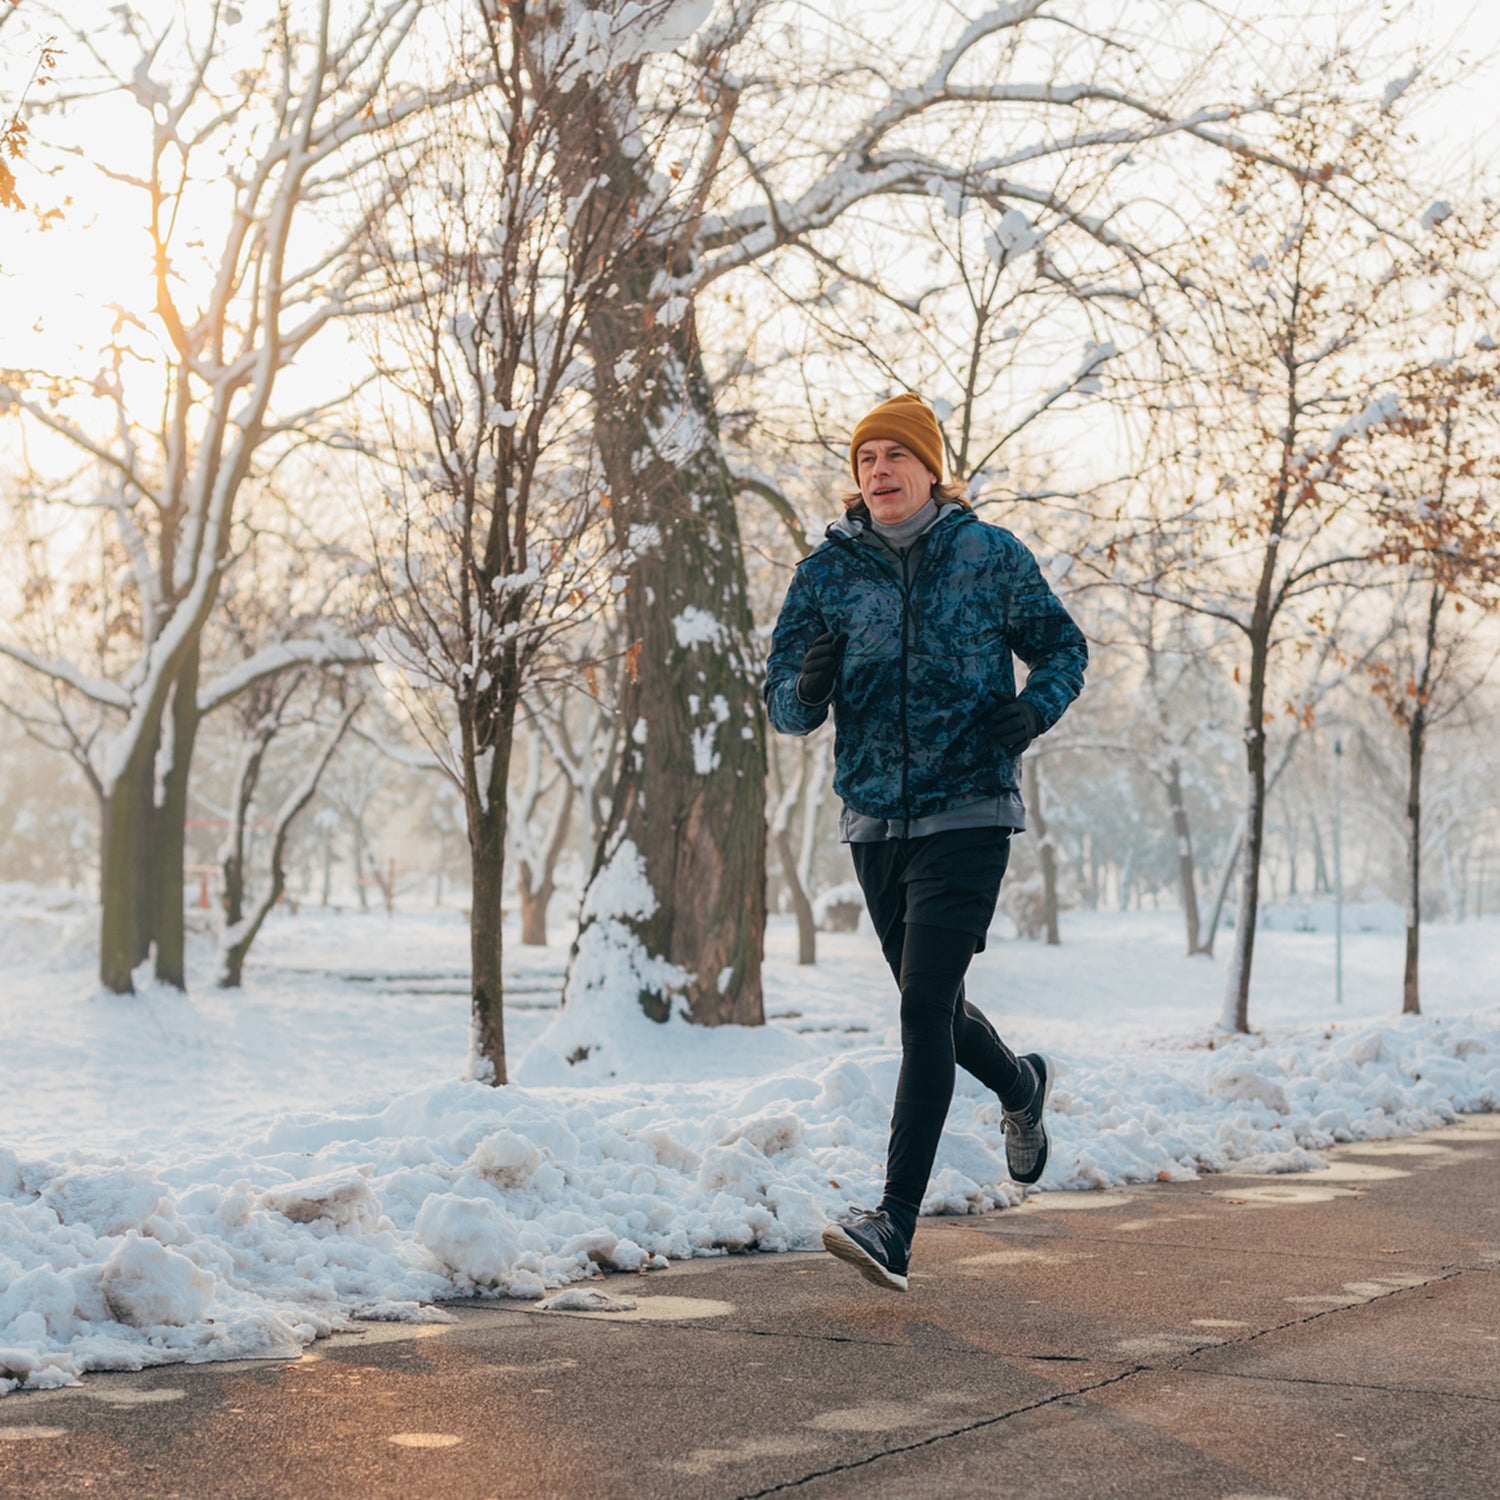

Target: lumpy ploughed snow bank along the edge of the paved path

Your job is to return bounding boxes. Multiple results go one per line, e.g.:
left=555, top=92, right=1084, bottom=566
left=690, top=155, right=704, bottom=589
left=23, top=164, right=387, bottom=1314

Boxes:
left=0, top=1011, right=1500, bottom=1389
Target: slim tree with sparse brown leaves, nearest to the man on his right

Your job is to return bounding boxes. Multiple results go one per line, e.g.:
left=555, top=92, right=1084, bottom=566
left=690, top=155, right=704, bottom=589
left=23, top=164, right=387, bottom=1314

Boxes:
left=1110, top=78, right=1458, bottom=1031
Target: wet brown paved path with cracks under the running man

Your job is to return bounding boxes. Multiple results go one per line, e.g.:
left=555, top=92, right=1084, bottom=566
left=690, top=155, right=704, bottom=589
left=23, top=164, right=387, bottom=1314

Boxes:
left=0, top=1116, right=1500, bottom=1500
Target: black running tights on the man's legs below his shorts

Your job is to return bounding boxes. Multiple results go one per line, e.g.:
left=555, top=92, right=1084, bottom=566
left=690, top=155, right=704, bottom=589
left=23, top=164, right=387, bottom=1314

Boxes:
left=882, top=923, right=1031, bottom=1233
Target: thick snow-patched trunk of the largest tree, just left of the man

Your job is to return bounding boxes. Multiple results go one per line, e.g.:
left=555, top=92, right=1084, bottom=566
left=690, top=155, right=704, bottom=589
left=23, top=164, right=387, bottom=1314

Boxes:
left=546, top=69, right=767, bottom=1026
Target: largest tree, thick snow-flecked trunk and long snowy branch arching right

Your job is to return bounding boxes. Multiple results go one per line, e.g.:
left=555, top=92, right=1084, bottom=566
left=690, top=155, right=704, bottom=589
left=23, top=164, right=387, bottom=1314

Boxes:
left=528, top=0, right=1308, bottom=1023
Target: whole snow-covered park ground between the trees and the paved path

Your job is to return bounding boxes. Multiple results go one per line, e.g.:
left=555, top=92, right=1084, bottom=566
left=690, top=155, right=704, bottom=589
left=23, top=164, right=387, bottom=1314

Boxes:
left=0, top=887, right=1500, bottom=1391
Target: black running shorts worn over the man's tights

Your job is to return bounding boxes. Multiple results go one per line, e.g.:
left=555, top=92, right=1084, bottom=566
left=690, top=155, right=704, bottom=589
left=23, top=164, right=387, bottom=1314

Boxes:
left=849, top=828, right=1011, bottom=953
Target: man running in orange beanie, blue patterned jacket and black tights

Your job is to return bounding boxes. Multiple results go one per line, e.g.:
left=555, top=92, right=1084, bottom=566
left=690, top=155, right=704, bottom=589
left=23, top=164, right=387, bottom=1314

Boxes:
left=765, top=395, right=1089, bottom=1292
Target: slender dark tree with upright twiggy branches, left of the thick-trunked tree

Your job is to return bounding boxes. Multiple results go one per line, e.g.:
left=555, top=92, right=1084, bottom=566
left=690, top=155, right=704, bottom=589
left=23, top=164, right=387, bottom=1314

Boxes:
left=363, top=6, right=651, bottom=1085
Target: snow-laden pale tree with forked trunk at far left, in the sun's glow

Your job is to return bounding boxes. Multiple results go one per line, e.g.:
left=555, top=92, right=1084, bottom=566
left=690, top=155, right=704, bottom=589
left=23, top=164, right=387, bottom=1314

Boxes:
left=0, top=0, right=441, bottom=993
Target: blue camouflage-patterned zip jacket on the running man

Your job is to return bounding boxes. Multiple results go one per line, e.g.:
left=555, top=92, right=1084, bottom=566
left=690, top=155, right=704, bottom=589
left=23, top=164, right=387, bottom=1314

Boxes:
left=765, top=509, right=1089, bottom=819
